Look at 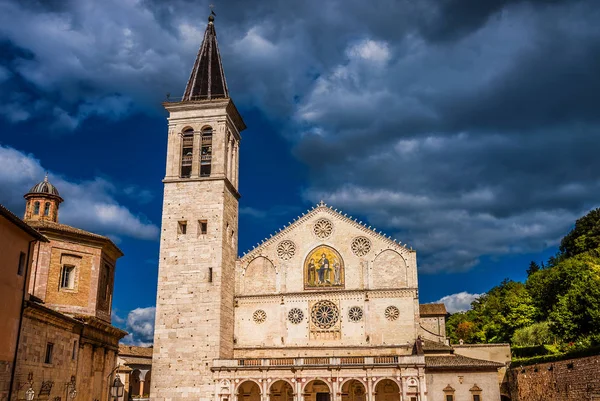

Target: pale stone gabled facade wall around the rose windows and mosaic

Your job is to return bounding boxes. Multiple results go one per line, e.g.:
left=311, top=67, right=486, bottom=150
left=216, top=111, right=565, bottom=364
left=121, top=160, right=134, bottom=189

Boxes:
left=235, top=206, right=419, bottom=357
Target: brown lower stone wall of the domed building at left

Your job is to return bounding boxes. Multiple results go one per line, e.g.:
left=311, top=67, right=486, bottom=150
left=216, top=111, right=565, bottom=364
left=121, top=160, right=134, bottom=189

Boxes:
left=12, top=305, right=120, bottom=401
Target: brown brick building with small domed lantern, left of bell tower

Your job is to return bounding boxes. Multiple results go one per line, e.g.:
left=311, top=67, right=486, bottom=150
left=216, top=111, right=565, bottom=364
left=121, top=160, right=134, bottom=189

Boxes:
left=2, top=177, right=127, bottom=401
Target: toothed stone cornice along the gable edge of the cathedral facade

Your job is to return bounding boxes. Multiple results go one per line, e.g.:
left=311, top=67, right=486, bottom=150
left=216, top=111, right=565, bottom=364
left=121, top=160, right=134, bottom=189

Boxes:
left=238, top=201, right=415, bottom=264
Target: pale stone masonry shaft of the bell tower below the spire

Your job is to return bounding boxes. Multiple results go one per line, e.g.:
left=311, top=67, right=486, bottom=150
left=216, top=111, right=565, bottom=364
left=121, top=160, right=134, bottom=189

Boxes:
left=150, top=102, right=238, bottom=401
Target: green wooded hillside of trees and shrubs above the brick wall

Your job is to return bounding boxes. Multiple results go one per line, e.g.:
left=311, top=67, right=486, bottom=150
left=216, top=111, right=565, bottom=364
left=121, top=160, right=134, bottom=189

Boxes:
left=447, top=208, right=600, bottom=359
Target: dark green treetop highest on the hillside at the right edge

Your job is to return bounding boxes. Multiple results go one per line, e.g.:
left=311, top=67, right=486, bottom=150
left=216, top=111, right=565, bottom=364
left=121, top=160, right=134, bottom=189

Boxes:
left=560, top=208, right=600, bottom=258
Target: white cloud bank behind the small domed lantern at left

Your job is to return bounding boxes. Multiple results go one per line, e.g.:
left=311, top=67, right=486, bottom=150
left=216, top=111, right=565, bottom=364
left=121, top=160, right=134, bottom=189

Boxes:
left=0, top=145, right=159, bottom=239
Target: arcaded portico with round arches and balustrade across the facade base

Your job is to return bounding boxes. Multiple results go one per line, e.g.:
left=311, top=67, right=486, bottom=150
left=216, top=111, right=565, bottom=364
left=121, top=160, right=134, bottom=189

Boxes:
left=213, top=356, right=427, bottom=401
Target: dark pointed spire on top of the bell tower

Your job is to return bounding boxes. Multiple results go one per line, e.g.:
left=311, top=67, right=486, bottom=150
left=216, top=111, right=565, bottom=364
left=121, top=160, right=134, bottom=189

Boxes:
left=183, top=12, right=229, bottom=102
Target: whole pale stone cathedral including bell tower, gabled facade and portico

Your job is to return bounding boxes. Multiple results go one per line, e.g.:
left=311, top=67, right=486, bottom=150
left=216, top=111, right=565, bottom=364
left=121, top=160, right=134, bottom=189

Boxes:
left=151, top=16, right=510, bottom=401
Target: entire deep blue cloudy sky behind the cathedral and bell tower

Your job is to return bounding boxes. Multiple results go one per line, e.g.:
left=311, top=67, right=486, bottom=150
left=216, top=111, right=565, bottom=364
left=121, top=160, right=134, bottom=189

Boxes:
left=0, top=0, right=600, bottom=344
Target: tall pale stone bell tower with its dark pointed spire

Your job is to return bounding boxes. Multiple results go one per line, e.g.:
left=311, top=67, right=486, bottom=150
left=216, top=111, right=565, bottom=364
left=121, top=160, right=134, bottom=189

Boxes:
left=151, top=11, right=246, bottom=401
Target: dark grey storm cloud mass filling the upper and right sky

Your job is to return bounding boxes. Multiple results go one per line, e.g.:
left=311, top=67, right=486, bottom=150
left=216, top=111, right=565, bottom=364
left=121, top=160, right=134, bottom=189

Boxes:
left=0, top=0, right=600, bottom=271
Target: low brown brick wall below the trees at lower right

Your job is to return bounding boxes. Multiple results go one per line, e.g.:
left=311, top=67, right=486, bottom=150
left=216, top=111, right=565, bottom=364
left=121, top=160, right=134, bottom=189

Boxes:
left=508, top=355, right=600, bottom=401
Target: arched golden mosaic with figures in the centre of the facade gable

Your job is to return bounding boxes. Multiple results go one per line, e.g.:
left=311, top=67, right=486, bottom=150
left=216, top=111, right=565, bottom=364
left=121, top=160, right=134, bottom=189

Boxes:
left=304, top=245, right=344, bottom=290
